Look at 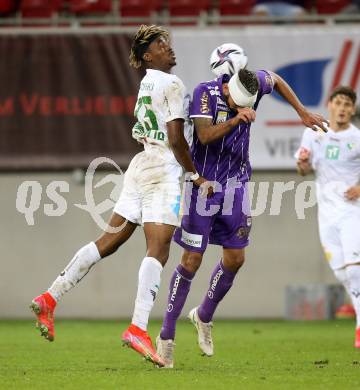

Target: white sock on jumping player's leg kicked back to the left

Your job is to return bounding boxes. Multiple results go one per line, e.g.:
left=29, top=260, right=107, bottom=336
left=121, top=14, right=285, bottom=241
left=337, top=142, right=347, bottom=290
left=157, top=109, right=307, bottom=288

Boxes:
left=48, top=242, right=101, bottom=301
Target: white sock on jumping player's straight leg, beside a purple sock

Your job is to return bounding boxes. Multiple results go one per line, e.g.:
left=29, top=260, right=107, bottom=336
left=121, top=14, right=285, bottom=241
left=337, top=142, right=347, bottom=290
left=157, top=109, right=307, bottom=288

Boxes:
left=131, top=257, right=163, bottom=330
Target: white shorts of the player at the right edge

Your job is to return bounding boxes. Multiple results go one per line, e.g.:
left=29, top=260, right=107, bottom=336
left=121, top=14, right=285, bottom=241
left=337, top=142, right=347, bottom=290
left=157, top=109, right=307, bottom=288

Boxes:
left=319, top=213, right=360, bottom=270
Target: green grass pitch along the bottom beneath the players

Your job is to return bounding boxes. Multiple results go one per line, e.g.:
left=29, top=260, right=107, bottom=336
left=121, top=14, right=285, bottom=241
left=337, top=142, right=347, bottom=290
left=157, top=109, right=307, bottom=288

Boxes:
left=0, top=321, right=360, bottom=390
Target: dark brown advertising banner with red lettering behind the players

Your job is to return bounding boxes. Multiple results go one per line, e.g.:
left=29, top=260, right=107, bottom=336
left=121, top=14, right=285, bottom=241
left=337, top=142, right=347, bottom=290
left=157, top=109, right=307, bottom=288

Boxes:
left=0, top=34, right=142, bottom=169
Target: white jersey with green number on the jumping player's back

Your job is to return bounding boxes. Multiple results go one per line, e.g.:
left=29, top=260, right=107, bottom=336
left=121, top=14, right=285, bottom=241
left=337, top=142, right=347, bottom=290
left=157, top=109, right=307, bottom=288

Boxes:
left=133, top=69, right=192, bottom=165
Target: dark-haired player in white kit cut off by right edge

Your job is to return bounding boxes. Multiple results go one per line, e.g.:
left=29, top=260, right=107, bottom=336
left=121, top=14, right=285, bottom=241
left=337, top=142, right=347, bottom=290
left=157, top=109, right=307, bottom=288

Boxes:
left=295, top=86, right=360, bottom=348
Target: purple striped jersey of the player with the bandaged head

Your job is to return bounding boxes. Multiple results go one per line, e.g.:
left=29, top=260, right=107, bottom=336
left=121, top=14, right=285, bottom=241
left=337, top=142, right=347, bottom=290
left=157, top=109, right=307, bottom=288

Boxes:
left=190, top=70, right=273, bottom=185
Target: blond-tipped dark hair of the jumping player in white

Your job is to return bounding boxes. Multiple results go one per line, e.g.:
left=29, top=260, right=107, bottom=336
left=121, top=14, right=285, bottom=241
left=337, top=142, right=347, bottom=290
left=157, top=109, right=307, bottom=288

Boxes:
left=129, top=24, right=169, bottom=69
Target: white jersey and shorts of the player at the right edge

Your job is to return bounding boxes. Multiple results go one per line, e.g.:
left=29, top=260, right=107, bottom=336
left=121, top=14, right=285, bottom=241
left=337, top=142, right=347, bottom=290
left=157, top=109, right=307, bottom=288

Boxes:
left=300, top=124, right=360, bottom=270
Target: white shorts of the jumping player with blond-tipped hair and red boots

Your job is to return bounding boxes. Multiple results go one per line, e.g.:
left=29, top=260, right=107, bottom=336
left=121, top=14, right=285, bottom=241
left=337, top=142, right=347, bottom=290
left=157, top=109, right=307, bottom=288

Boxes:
left=114, top=152, right=182, bottom=226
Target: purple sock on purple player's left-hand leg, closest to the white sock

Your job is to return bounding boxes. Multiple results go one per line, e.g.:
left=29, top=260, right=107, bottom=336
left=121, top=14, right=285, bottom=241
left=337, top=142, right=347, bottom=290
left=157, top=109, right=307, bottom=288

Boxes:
left=160, top=264, right=195, bottom=340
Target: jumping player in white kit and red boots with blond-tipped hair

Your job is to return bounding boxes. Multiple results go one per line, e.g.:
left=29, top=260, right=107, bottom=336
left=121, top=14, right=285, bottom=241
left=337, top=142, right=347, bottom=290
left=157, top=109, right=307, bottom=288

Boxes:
left=31, top=25, right=210, bottom=366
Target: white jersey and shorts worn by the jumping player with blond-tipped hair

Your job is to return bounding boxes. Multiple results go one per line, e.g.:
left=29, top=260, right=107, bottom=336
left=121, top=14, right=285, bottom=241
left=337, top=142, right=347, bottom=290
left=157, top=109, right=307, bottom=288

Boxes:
left=114, top=69, right=191, bottom=226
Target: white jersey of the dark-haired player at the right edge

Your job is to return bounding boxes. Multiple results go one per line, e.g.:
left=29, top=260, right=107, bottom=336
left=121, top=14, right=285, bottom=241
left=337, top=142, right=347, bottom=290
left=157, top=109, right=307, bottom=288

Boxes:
left=296, top=125, right=360, bottom=223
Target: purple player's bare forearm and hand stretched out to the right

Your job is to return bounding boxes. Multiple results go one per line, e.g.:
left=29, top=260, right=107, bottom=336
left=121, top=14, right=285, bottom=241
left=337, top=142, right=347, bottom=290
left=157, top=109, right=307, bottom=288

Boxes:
left=271, top=72, right=329, bottom=132
